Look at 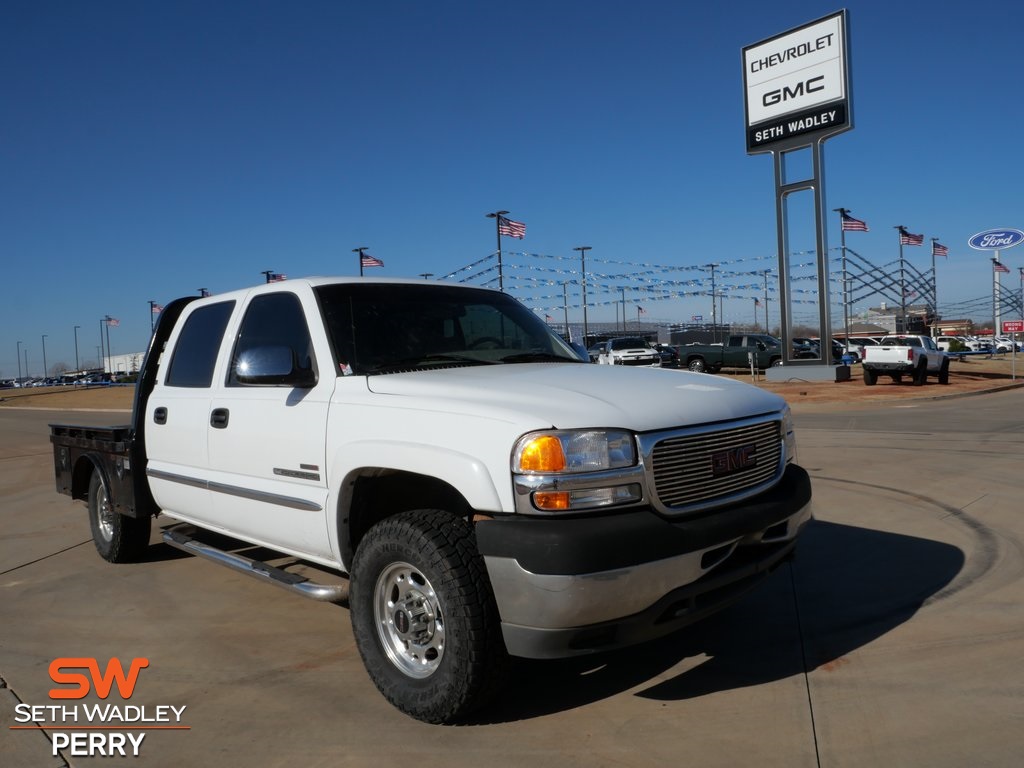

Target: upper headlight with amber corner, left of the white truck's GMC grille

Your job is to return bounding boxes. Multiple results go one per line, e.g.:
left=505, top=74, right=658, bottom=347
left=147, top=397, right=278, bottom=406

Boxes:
left=512, top=429, right=636, bottom=474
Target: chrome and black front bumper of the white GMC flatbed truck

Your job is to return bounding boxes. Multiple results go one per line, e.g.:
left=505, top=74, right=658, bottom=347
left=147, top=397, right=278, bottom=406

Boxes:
left=477, top=466, right=812, bottom=658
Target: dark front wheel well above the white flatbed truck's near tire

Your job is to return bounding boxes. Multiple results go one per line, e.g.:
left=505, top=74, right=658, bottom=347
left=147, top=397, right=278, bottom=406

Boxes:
left=338, top=469, right=472, bottom=563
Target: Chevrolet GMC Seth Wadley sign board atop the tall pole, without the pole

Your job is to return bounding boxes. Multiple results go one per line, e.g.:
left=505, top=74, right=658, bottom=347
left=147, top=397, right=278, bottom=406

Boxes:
left=743, top=12, right=851, bottom=153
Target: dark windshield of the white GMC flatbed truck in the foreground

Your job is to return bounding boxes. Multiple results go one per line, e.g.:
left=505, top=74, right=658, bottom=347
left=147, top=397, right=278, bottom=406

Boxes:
left=316, top=283, right=583, bottom=376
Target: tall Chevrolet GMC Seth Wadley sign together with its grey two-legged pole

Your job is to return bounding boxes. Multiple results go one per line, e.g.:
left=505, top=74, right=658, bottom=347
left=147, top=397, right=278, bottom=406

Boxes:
left=742, top=10, right=853, bottom=370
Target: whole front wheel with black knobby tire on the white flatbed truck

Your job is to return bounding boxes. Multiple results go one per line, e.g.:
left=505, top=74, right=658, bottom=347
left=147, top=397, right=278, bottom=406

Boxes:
left=349, top=510, right=508, bottom=723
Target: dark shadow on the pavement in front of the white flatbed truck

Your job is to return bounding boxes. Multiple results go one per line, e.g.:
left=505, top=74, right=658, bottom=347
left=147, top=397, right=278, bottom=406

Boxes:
left=474, top=521, right=962, bottom=724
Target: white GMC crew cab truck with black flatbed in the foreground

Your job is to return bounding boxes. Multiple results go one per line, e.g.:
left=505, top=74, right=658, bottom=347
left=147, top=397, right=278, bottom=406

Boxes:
left=51, top=278, right=811, bottom=723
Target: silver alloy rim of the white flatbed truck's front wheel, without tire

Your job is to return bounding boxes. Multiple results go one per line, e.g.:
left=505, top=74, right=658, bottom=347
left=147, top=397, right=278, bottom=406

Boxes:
left=374, top=562, right=444, bottom=679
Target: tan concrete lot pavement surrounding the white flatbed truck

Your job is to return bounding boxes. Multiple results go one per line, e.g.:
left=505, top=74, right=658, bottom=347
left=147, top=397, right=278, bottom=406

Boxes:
left=0, top=389, right=1024, bottom=768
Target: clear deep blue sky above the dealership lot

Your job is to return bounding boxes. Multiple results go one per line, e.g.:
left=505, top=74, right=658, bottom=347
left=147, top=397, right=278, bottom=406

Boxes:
left=0, top=0, right=1024, bottom=377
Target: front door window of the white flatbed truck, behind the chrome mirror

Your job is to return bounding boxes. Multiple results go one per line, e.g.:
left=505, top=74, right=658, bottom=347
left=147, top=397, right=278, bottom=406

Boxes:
left=227, top=292, right=315, bottom=387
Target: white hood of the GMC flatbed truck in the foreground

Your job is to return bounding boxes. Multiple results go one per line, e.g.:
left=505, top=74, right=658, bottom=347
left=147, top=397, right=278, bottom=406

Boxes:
left=367, top=364, right=785, bottom=432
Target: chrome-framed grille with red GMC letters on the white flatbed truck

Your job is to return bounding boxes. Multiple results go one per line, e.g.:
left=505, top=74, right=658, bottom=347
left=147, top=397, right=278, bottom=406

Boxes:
left=650, top=420, right=782, bottom=512
